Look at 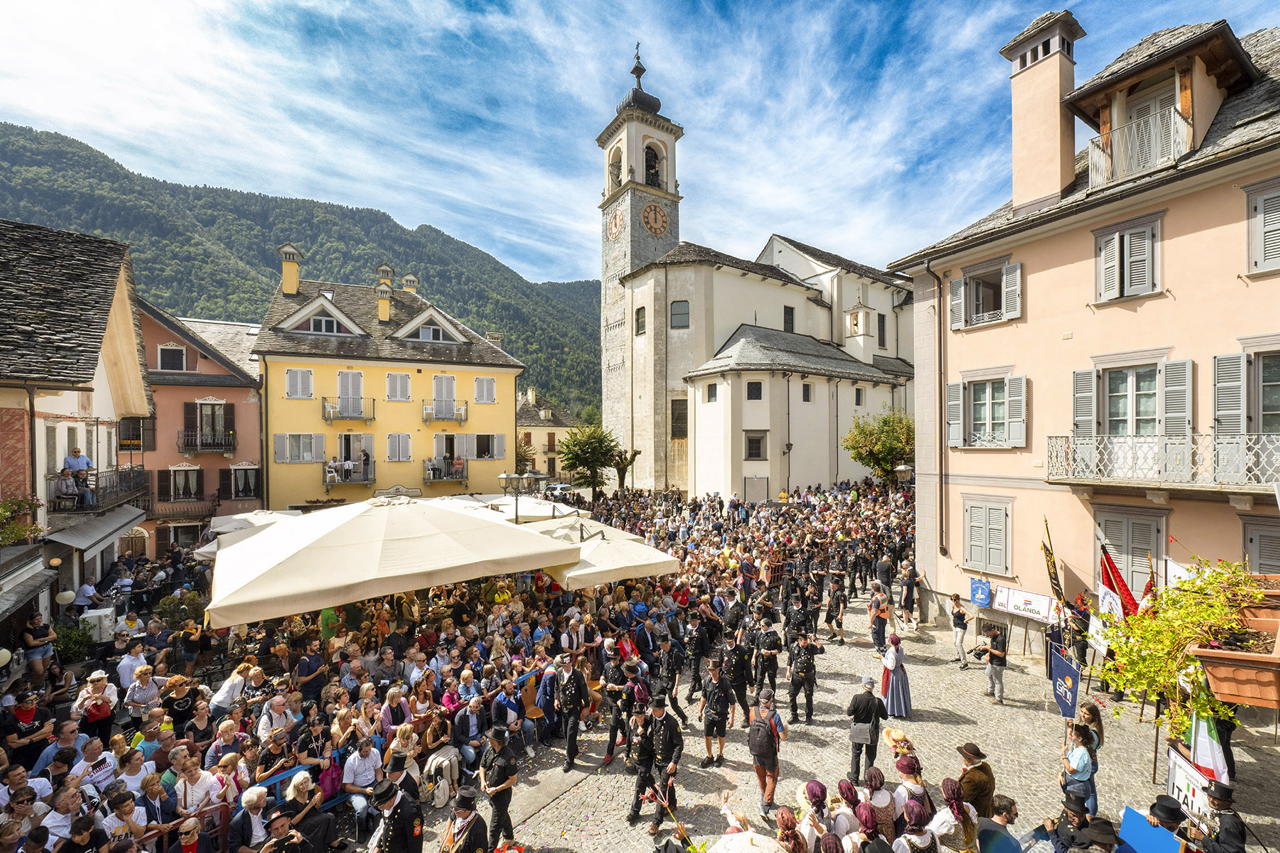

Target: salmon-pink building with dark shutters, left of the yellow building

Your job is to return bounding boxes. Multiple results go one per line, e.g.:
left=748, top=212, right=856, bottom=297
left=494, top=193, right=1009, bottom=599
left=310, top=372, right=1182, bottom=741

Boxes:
left=119, top=298, right=262, bottom=556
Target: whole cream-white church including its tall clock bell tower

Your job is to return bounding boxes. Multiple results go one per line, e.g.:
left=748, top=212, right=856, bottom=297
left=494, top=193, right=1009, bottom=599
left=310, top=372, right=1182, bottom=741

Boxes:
left=596, top=56, right=913, bottom=501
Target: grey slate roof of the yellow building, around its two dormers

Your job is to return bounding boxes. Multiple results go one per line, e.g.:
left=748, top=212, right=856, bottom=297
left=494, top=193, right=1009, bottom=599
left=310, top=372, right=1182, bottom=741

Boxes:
left=253, top=280, right=525, bottom=369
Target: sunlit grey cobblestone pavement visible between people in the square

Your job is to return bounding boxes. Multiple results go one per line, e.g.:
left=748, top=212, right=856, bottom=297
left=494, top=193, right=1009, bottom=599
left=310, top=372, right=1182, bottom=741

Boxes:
left=414, top=606, right=1280, bottom=853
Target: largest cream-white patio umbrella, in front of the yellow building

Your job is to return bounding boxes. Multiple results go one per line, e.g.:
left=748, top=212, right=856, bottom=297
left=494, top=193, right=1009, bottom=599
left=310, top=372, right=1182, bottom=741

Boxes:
left=205, top=497, right=579, bottom=628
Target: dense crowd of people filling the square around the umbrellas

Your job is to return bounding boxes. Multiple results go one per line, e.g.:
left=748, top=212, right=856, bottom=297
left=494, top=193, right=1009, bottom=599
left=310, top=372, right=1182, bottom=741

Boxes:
left=0, top=482, right=1243, bottom=853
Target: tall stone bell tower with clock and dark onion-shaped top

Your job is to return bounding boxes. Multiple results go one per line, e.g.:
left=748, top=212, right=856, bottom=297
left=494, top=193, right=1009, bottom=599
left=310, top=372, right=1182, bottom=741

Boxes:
left=595, top=45, right=685, bottom=446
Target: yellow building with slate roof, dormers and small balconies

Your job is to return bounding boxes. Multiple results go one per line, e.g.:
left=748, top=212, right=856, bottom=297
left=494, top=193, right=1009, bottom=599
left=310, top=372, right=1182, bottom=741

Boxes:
left=253, top=243, right=525, bottom=510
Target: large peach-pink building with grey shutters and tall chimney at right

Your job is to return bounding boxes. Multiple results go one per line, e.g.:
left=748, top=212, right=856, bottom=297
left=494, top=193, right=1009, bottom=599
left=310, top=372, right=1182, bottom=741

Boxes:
left=891, top=12, right=1280, bottom=621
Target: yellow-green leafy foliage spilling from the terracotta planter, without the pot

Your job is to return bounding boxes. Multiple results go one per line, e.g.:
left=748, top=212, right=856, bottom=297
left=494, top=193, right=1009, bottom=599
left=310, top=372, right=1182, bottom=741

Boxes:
left=1098, top=558, right=1263, bottom=738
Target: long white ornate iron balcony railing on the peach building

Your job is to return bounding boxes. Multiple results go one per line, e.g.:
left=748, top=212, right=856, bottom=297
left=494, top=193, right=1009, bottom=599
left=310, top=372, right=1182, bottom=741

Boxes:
left=1048, top=433, right=1280, bottom=493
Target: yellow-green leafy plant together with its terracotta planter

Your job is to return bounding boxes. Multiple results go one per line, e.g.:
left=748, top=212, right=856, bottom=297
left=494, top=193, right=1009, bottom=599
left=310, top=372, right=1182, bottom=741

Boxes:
left=1100, top=558, right=1280, bottom=738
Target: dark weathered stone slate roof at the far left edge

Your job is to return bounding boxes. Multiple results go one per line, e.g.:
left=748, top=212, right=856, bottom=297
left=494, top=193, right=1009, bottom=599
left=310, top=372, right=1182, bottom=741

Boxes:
left=0, top=219, right=129, bottom=383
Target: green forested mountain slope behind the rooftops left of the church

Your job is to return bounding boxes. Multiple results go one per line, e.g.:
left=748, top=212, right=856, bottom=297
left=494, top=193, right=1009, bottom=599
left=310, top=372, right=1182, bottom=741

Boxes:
left=0, top=122, right=600, bottom=410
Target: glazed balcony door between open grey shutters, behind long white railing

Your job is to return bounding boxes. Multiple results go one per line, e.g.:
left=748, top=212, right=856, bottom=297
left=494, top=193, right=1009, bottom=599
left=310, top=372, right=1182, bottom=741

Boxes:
left=1102, top=364, right=1161, bottom=480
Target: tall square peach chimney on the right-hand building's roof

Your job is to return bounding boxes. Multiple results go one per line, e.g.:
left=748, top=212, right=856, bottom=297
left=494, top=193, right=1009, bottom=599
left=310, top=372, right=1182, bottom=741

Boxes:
left=1000, top=10, right=1084, bottom=215
